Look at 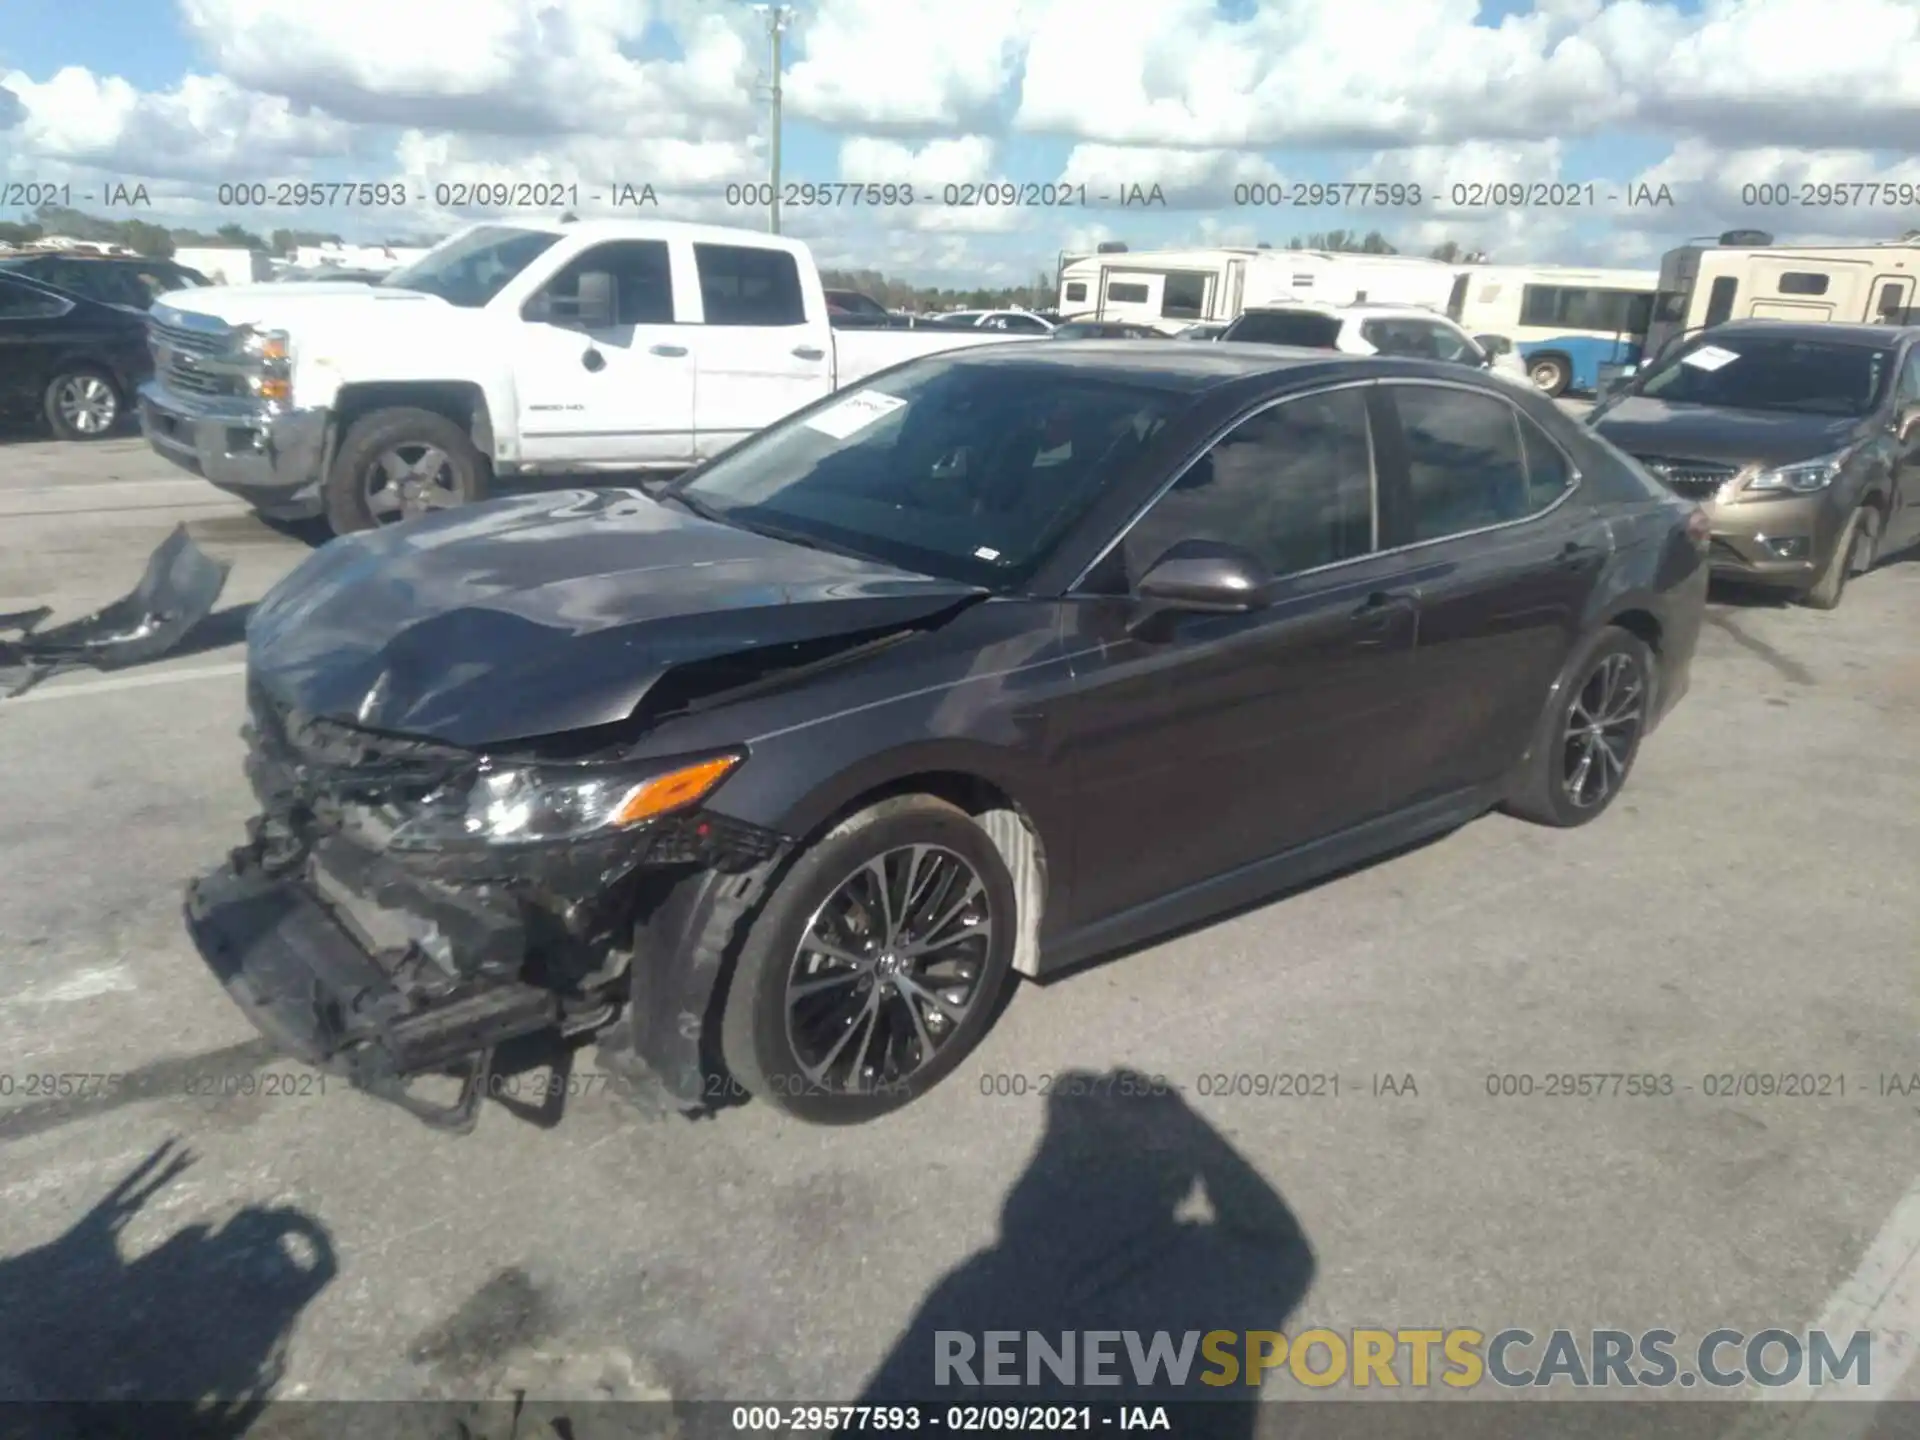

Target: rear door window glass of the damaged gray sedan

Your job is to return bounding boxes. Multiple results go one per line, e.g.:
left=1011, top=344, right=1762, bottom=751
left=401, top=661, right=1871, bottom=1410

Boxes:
left=1392, top=386, right=1534, bottom=540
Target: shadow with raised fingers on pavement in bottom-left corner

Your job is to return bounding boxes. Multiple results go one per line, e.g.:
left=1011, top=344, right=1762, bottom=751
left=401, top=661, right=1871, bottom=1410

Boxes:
left=0, top=1140, right=338, bottom=1440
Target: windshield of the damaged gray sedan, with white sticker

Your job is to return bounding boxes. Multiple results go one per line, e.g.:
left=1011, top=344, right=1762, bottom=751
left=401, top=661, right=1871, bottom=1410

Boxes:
left=668, top=355, right=1185, bottom=589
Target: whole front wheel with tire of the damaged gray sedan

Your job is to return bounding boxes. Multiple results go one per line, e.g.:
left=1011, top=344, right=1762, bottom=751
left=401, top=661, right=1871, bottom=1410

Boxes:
left=720, top=795, right=1016, bottom=1125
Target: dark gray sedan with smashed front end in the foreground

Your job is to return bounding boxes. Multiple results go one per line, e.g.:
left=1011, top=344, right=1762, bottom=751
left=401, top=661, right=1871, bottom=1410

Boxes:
left=186, top=342, right=1705, bottom=1129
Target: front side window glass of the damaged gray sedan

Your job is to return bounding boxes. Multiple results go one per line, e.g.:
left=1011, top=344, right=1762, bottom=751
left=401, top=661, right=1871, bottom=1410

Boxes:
left=1112, top=388, right=1373, bottom=586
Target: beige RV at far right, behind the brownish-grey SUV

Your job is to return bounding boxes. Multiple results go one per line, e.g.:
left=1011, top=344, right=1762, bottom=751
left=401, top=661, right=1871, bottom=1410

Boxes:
left=1645, top=230, right=1920, bottom=357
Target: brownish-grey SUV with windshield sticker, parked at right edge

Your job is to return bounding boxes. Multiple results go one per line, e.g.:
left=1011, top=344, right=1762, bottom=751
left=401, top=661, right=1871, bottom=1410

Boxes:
left=1588, top=321, right=1920, bottom=611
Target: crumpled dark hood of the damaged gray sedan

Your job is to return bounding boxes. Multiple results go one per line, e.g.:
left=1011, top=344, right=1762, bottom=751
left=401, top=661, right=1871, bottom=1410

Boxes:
left=248, top=490, right=985, bottom=747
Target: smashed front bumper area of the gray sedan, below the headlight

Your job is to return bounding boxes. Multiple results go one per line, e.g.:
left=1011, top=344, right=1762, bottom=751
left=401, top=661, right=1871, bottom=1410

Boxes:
left=186, top=699, right=783, bottom=1131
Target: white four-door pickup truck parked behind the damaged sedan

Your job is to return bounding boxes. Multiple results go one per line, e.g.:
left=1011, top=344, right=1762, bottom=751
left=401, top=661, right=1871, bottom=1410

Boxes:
left=140, top=221, right=1020, bottom=532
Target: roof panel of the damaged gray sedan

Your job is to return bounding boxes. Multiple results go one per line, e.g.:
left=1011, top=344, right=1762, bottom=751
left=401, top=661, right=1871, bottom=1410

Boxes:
left=927, top=338, right=1505, bottom=394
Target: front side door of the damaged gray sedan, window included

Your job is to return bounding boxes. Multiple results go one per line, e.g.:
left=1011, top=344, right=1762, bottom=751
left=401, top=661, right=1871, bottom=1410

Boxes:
left=1060, top=384, right=1415, bottom=927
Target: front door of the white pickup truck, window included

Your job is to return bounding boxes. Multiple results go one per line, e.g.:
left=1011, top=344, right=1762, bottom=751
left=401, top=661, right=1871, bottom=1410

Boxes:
left=511, top=240, right=699, bottom=467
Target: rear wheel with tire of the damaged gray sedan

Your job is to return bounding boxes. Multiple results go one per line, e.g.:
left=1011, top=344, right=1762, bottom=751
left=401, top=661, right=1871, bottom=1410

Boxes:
left=1501, top=626, right=1653, bottom=829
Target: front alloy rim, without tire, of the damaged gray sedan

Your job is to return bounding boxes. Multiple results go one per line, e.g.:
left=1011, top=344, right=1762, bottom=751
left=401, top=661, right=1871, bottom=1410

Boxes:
left=785, top=845, right=995, bottom=1094
